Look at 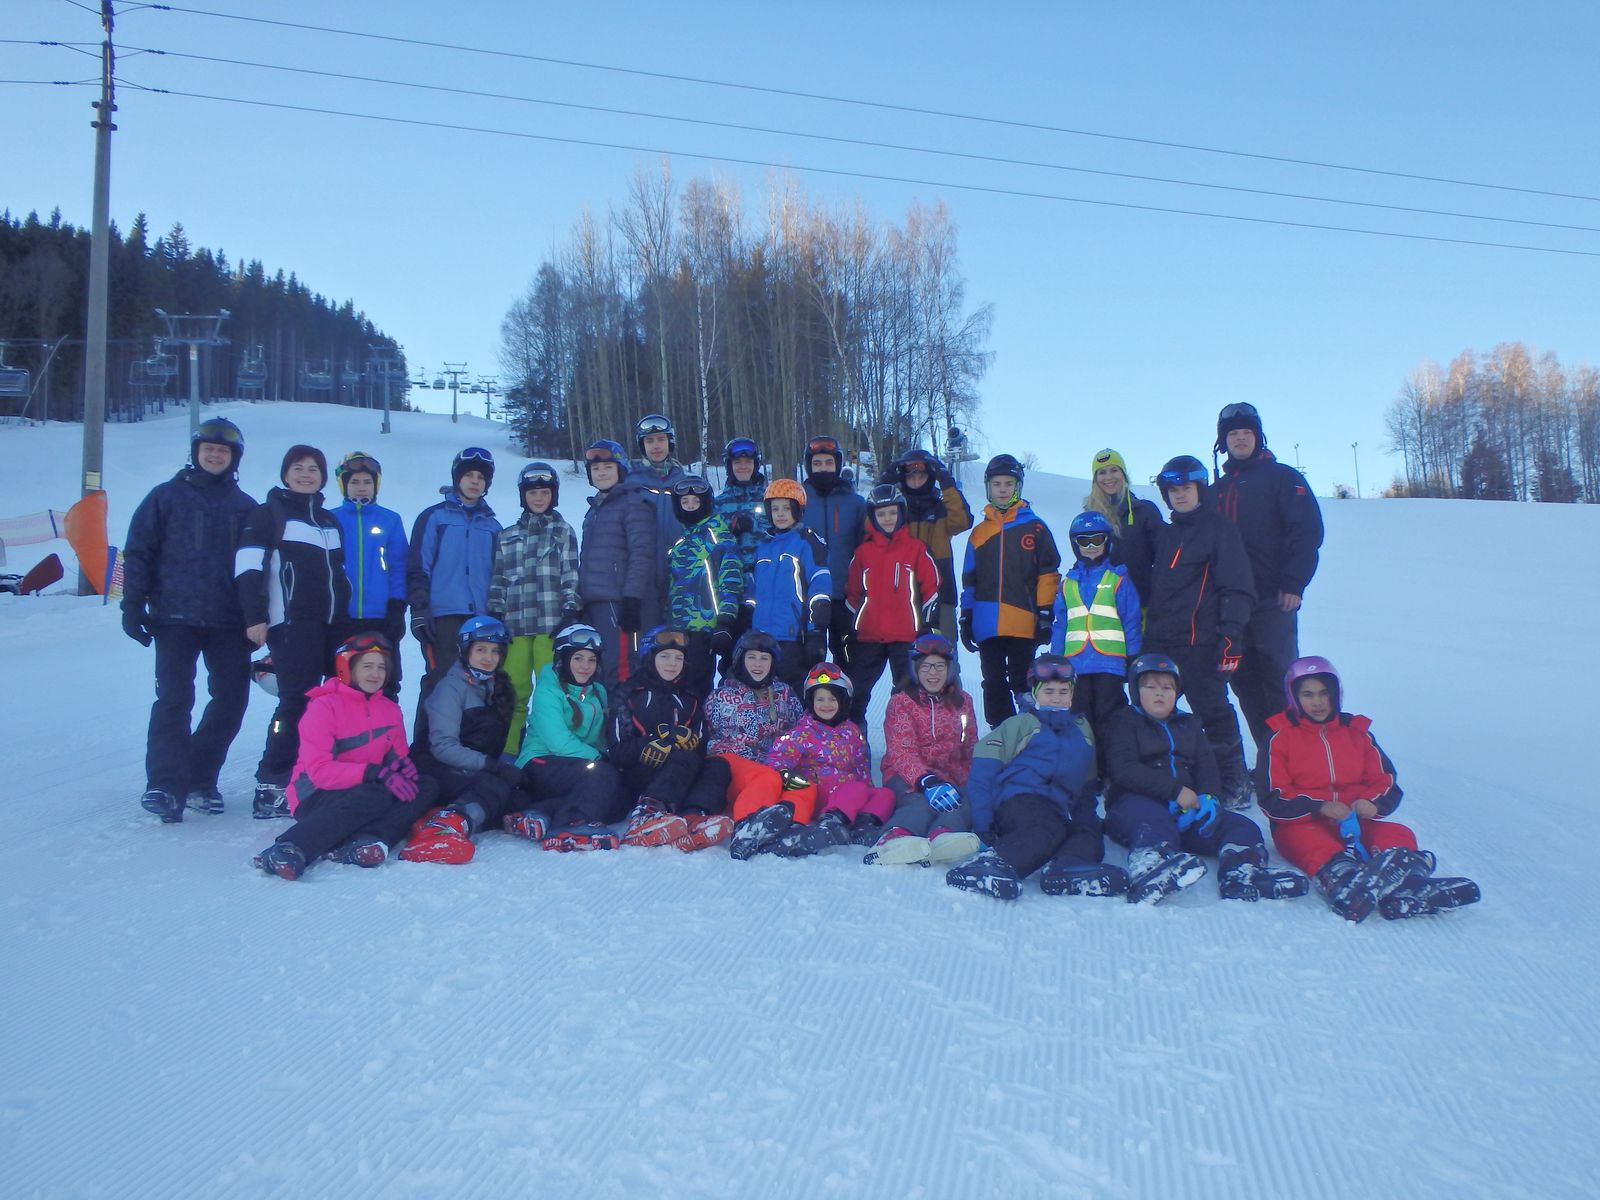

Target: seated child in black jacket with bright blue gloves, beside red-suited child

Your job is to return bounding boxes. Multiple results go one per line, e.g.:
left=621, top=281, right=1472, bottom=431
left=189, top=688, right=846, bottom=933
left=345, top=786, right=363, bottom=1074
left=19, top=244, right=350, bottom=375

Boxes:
left=1104, top=653, right=1307, bottom=904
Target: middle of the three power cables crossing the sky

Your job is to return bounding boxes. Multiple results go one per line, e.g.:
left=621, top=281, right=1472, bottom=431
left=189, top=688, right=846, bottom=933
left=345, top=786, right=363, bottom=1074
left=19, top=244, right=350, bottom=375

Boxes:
left=118, top=43, right=1600, bottom=234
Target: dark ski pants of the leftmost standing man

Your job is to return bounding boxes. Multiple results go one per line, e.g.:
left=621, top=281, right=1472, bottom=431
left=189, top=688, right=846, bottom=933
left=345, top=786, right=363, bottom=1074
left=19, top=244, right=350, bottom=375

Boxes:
left=144, top=626, right=251, bottom=800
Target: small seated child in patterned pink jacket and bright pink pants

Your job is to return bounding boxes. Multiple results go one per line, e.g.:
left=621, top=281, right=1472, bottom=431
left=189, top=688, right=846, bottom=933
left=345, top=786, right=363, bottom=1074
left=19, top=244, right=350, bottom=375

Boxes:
left=728, top=662, right=894, bottom=859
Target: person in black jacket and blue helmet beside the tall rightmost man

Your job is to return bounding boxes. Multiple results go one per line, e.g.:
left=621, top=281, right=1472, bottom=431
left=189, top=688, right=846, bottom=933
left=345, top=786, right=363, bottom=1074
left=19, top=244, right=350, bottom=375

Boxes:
left=1144, top=454, right=1256, bottom=806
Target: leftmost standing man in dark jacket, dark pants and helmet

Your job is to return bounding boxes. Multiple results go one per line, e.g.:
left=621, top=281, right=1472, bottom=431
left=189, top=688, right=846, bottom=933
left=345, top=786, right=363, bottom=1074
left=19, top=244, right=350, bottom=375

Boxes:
left=122, top=418, right=256, bottom=822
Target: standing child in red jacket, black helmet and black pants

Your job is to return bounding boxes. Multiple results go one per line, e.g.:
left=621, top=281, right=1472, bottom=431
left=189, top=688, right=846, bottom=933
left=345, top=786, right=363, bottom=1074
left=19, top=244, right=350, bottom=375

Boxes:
left=845, top=483, right=939, bottom=734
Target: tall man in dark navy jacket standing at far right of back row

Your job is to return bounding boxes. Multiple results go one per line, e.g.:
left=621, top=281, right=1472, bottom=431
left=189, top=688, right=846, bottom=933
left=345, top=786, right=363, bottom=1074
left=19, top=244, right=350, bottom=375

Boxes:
left=1216, top=403, right=1322, bottom=795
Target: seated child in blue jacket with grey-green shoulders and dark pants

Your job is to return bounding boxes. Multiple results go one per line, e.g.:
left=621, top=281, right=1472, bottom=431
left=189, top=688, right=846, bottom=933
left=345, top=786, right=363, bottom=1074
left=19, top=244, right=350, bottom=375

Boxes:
left=944, top=654, right=1109, bottom=899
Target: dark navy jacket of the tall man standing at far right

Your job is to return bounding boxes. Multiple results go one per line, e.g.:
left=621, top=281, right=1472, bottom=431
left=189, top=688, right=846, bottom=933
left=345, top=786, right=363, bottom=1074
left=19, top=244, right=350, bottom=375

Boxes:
left=1211, top=450, right=1322, bottom=603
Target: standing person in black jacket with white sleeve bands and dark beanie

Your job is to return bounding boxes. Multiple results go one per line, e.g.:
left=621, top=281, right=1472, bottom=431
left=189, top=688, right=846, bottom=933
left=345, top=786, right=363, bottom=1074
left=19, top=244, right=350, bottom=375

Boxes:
left=234, top=445, right=350, bottom=819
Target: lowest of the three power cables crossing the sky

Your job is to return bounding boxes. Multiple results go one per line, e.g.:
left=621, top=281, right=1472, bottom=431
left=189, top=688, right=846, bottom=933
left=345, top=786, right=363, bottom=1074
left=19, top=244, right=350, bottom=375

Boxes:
left=123, top=78, right=1600, bottom=258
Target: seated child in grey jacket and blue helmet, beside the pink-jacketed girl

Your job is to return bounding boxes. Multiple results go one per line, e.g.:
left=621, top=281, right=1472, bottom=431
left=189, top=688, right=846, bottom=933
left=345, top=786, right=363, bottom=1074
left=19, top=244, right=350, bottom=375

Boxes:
left=400, top=616, right=528, bottom=864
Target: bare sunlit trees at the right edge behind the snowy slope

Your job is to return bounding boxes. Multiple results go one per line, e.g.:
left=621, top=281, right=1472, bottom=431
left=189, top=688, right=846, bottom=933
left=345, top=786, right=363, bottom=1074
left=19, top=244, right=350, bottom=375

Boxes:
left=1386, top=342, right=1600, bottom=504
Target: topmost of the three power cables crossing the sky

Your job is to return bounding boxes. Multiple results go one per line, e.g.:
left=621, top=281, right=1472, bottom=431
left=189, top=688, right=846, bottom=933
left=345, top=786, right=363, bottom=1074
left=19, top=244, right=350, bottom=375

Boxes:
left=147, top=3, right=1600, bottom=203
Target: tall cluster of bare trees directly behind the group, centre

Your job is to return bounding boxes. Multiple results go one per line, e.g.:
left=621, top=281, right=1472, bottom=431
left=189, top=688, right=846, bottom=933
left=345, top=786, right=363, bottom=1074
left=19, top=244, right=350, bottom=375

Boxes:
left=501, top=163, right=994, bottom=464
